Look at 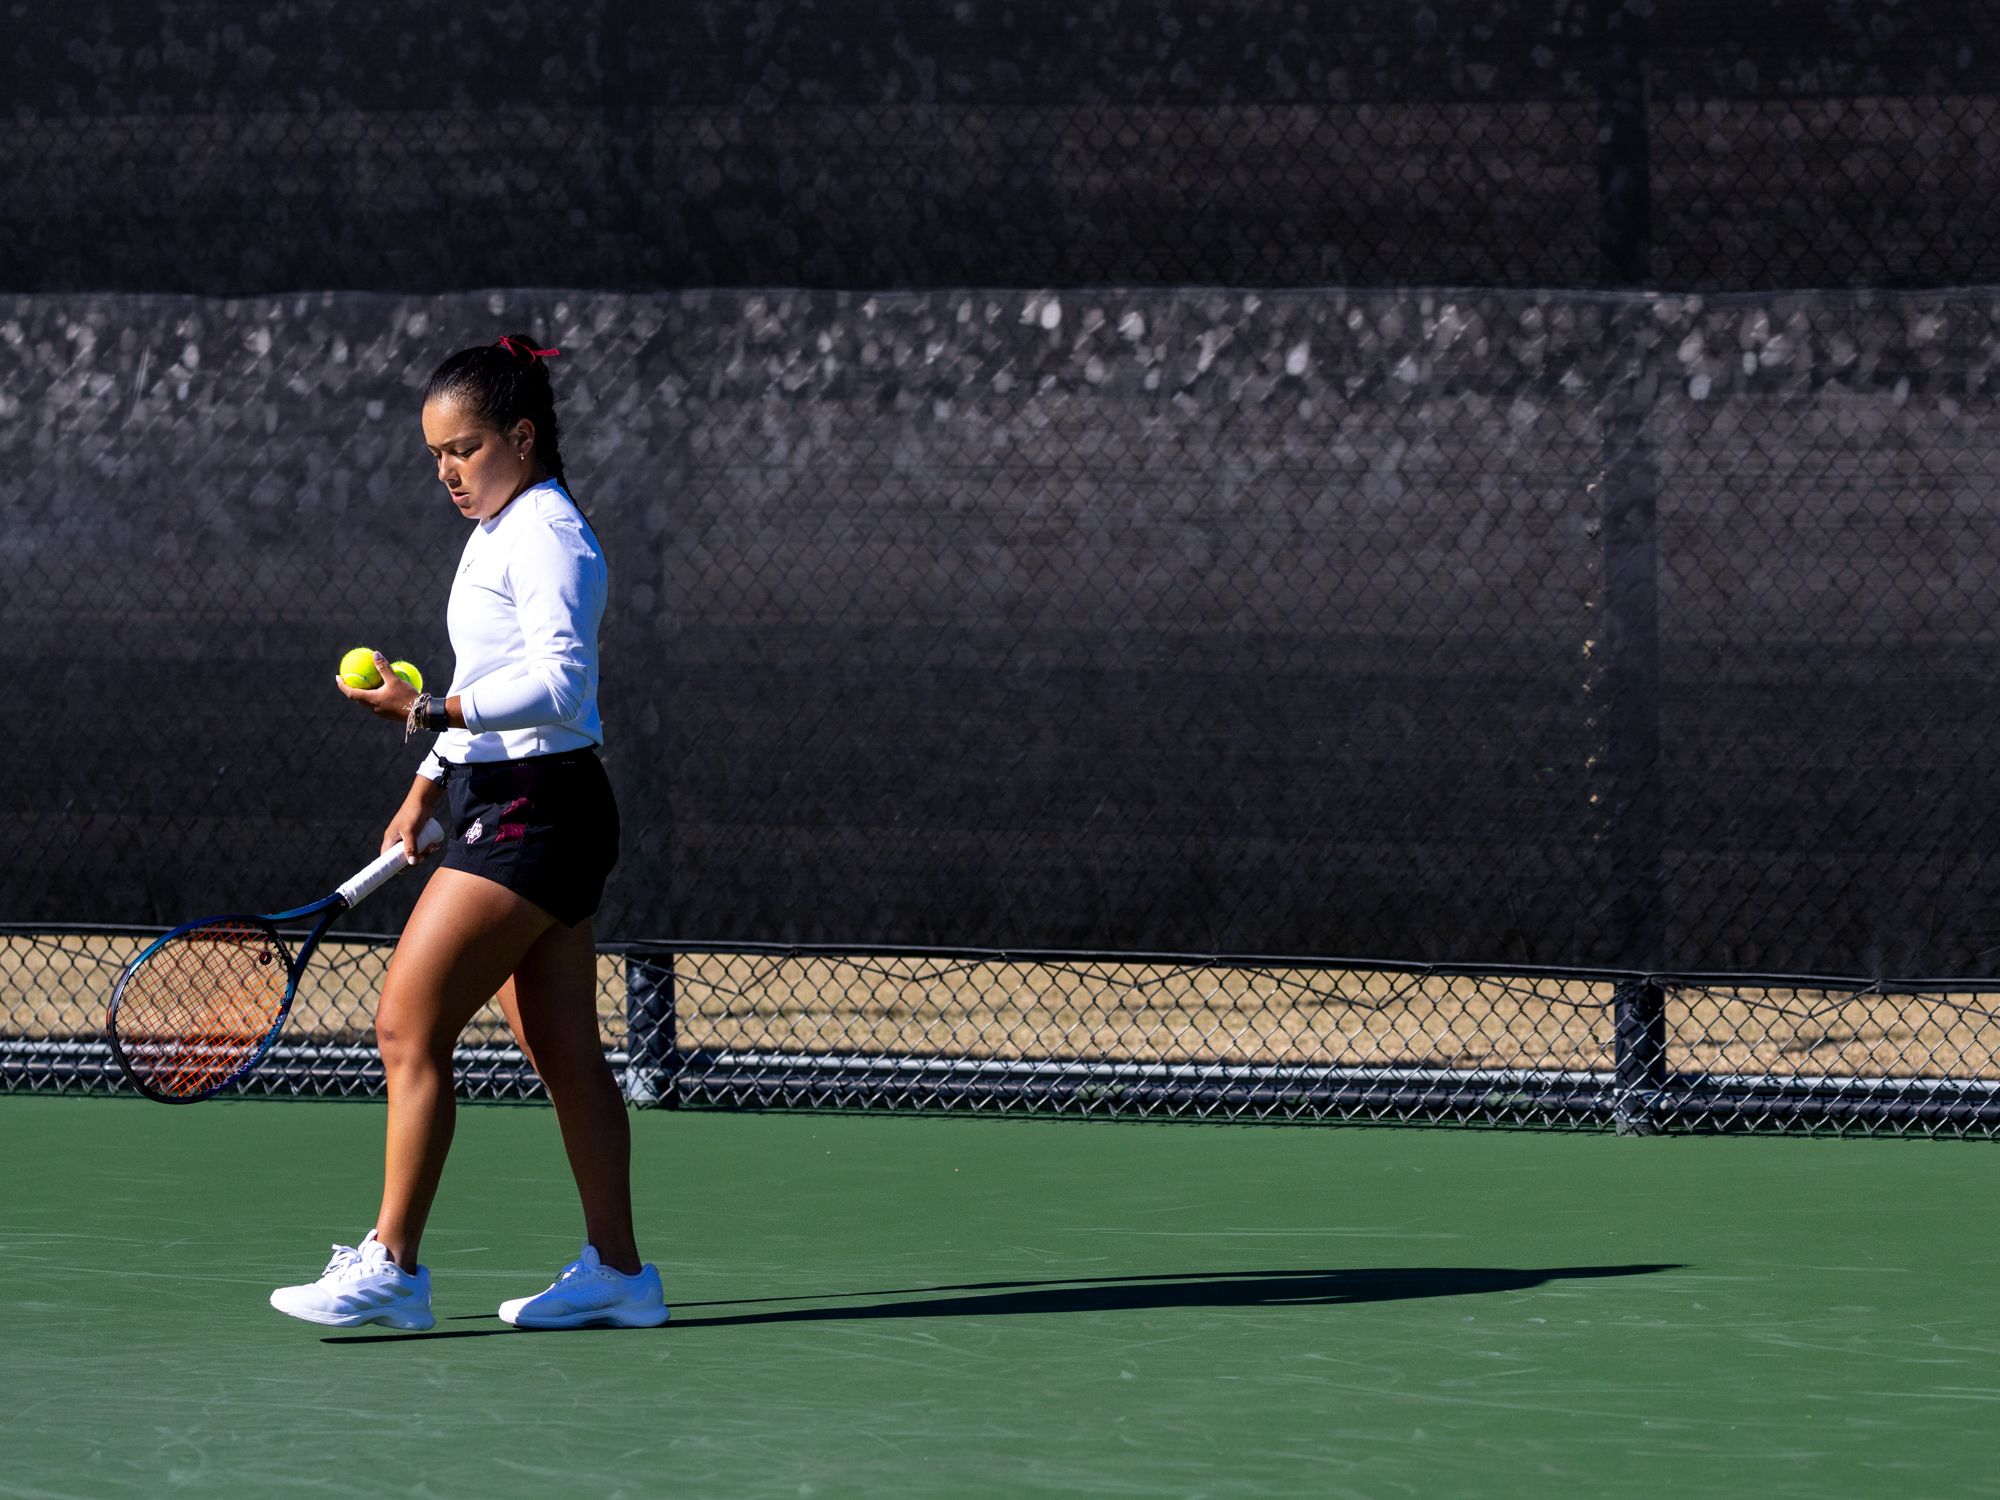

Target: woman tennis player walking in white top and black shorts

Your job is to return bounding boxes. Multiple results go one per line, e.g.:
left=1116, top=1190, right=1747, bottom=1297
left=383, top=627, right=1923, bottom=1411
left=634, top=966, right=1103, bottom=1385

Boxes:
left=270, top=336, right=668, bottom=1328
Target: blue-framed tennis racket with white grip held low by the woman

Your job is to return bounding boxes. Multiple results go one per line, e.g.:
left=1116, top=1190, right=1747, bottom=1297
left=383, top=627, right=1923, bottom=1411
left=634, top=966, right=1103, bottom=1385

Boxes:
left=104, top=818, right=444, bottom=1104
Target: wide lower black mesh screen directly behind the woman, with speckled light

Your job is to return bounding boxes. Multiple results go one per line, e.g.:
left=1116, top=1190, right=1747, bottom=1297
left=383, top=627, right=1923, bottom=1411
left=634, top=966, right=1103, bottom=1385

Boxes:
left=0, top=290, right=2000, bottom=972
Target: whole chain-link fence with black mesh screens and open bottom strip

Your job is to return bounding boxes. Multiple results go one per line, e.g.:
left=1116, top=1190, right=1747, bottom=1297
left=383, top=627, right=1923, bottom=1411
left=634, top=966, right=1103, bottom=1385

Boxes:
left=11, top=0, right=2000, bottom=1128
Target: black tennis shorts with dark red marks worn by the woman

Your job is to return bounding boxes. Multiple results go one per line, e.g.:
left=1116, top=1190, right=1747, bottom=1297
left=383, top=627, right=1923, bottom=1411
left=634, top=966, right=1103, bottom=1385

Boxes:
left=444, top=750, right=618, bottom=928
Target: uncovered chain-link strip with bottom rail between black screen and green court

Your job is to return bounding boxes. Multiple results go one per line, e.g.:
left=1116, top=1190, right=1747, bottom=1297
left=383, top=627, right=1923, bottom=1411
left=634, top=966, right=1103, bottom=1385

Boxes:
left=0, top=928, right=2000, bottom=1136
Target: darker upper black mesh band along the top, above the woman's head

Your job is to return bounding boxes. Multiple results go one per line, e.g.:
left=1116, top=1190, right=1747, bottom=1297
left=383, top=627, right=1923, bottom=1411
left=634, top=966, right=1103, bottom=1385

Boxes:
left=0, top=0, right=2000, bottom=296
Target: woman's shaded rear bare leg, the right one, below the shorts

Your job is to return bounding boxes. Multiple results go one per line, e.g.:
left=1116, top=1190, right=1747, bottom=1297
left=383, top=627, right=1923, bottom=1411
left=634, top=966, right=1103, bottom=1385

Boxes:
left=500, top=918, right=640, bottom=1276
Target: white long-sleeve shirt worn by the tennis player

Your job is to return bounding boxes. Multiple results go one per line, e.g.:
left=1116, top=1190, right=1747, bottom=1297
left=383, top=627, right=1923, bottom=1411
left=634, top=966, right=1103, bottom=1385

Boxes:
left=418, top=480, right=606, bottom=782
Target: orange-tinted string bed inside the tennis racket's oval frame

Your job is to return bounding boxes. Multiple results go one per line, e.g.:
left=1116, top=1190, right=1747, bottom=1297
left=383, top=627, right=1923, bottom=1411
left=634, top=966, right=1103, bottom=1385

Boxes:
left=114, top=922, right=290, bottom=1098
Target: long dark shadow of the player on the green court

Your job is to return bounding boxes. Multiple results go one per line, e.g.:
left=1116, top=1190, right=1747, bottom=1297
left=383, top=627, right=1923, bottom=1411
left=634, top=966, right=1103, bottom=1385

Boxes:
left=324, top=1264, right=1680, bottom=1344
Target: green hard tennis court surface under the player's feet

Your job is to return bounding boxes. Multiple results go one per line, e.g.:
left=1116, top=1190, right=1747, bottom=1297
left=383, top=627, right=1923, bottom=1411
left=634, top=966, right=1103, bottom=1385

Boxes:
left=0, top=1096, right=2000, bottom=1498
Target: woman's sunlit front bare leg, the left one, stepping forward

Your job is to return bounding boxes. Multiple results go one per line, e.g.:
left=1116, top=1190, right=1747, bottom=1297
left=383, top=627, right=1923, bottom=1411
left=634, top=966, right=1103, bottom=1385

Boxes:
left=376, top=870, right=556, bottom=1270
